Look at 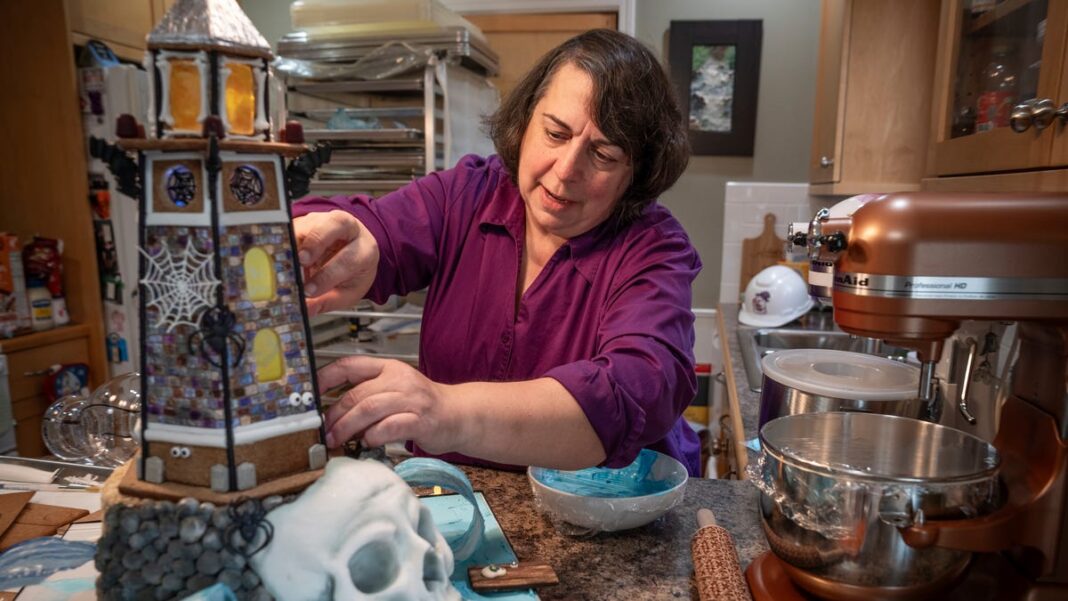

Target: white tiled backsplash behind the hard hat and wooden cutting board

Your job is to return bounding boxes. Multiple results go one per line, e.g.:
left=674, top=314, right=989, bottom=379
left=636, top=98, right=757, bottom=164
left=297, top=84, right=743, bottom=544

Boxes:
left=720, top=181, right=841, bottom=303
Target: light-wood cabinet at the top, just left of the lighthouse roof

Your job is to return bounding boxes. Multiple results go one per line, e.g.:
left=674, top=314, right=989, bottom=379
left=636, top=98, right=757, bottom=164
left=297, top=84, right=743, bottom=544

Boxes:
left=66, top=0, right=175, bottom=63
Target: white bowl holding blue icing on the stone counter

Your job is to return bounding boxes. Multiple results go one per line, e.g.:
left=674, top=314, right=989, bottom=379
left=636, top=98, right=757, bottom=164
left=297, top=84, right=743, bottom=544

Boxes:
left=527, top=448, right=688, bottom=532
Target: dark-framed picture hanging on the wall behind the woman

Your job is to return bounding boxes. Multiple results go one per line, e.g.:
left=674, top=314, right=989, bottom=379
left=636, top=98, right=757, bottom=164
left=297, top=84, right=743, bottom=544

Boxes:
left=668, top=20, right=764, bottom=156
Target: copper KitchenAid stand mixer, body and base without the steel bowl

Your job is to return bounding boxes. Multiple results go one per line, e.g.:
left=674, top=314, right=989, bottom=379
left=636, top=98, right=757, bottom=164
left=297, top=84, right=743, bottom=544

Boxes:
left=747, top=192, right=1068, bottom=601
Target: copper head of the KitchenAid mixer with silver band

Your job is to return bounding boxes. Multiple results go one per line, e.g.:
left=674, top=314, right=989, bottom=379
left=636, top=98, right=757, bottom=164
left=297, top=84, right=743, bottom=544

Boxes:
left=806, top=192, right=1068, bottom=361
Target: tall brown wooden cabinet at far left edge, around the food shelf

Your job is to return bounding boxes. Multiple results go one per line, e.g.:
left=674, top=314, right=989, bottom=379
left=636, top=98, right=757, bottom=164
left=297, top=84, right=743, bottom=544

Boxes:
left=0, top=0, right=107, bottom=455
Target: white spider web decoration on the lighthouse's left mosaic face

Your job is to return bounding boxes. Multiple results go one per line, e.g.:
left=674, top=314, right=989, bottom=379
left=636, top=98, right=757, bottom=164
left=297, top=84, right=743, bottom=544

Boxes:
left=138, top=236, right=219, bottom=332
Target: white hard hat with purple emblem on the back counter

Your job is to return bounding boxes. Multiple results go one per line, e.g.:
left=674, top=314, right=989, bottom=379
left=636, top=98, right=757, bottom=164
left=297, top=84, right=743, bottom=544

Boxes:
left=738, top=265, right=814, bottom=328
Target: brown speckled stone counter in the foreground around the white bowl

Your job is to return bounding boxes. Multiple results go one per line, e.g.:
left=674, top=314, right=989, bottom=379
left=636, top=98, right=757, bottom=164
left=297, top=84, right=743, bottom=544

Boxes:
left=465, top=468, right=768, bottom=600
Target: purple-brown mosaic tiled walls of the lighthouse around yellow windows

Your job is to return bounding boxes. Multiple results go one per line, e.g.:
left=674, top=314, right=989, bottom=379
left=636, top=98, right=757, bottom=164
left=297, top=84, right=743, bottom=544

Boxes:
left=144, top=223, right=315, bottom=428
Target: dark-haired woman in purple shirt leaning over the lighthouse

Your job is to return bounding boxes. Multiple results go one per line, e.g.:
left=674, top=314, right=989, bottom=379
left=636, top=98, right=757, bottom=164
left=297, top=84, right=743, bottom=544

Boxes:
left=294, top=30, right=701, bottom=475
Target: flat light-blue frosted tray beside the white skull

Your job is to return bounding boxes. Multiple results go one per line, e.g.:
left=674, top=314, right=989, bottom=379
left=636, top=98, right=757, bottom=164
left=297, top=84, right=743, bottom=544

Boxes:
left=420, top=492, right=538, bottom=601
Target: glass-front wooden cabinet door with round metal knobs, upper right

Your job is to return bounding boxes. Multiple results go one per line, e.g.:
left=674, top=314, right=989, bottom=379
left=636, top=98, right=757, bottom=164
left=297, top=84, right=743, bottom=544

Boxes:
left=930, top=0, right=1068, bottom=175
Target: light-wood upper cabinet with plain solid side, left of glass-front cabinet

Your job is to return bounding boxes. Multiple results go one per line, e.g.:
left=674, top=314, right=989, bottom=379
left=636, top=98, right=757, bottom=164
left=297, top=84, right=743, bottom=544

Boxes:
left=810, top=0, right=939, bottom=194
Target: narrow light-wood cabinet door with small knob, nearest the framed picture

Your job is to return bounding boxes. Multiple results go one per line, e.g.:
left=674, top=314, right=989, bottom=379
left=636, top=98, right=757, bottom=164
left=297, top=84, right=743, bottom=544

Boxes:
left=808, top=0, right=851, bottom=184
